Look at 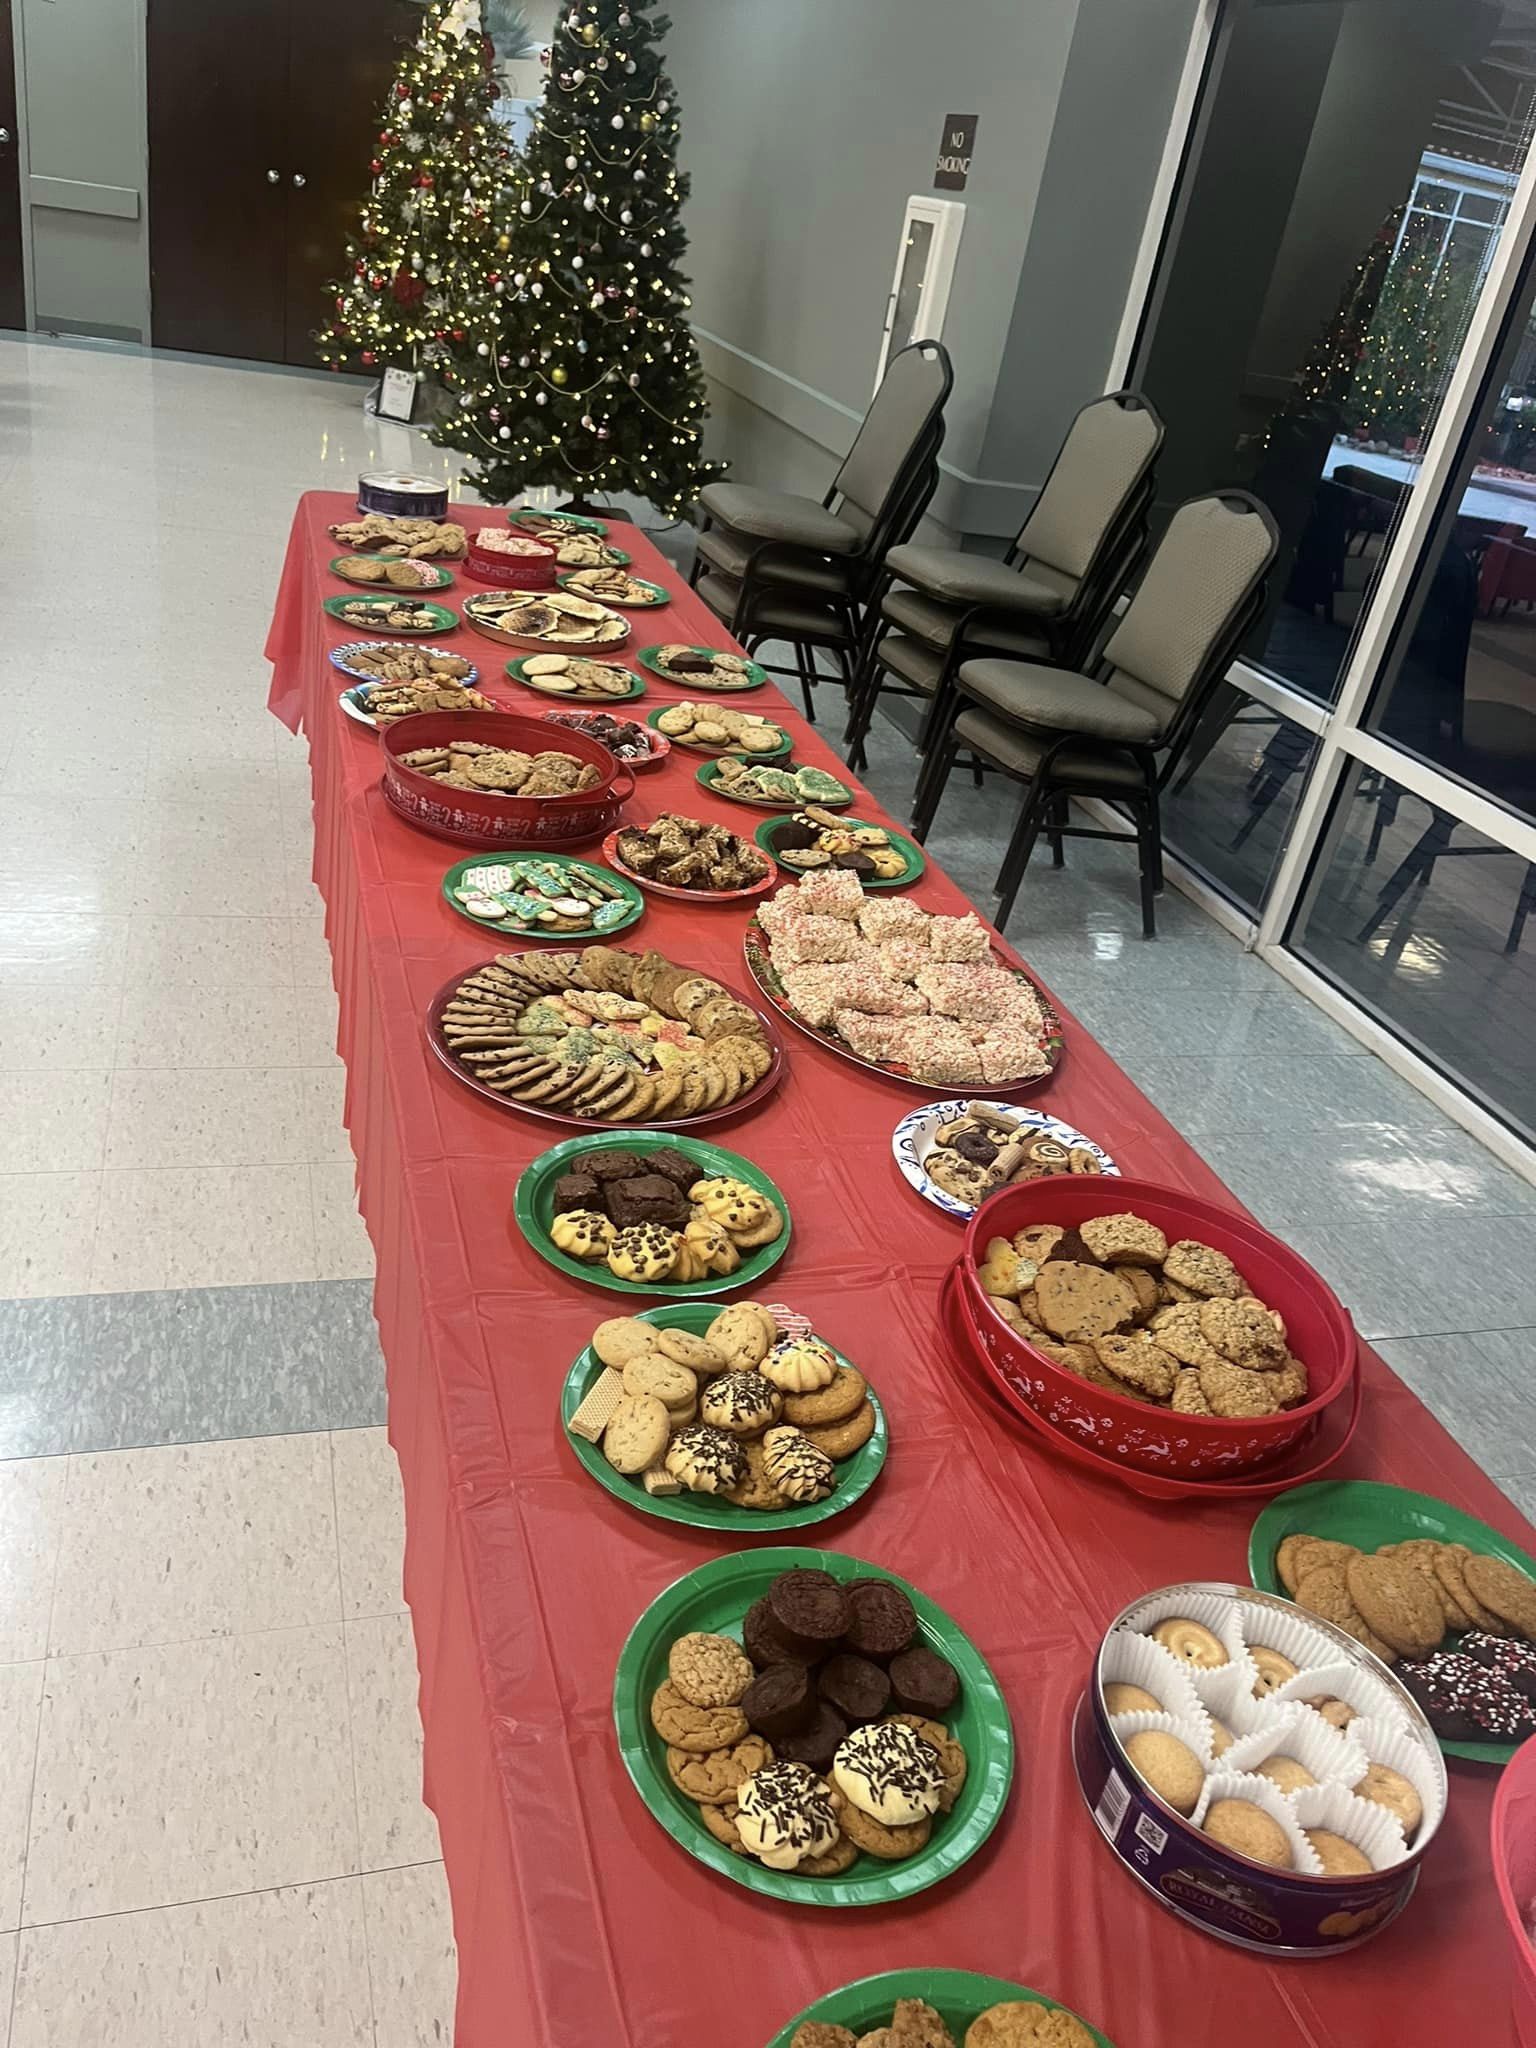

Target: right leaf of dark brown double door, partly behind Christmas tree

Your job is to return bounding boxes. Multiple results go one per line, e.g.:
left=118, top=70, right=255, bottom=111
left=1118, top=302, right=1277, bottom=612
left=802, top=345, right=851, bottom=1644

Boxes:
left=285, top=0, right=422, bottom=362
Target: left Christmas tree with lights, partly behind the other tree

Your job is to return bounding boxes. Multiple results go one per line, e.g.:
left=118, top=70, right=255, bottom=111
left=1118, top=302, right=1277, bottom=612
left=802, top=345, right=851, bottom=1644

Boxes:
left=315, top=0, right=512, bottom=385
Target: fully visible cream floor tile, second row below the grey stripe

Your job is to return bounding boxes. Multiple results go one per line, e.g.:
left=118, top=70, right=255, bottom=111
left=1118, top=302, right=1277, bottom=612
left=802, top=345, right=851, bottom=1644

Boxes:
left=24, top=1626, right=356, bottom=1927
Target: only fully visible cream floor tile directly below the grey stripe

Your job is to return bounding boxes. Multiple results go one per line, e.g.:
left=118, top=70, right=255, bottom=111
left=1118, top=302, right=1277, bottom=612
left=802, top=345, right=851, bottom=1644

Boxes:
left=52, top=1434, right=342, bottom=1657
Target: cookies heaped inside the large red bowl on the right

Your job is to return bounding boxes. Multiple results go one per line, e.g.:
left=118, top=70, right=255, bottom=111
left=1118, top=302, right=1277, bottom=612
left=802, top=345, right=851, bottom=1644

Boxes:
left=977, top=1210, right=1309, bottom=1417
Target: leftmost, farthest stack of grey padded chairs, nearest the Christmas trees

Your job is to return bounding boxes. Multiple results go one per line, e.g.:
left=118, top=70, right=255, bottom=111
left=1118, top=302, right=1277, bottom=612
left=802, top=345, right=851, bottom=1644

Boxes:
left=690, top=342, right=954, bottom=719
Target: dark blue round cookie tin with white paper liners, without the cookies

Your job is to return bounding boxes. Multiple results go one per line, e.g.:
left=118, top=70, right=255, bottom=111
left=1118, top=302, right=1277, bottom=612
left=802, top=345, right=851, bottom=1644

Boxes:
left=1071, top=1581, right=1446, bottom=1956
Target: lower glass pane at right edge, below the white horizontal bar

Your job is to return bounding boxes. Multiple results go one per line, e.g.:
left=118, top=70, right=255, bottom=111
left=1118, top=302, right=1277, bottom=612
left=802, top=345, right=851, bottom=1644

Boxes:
left=1290, top=764, right=1536, bottom=1139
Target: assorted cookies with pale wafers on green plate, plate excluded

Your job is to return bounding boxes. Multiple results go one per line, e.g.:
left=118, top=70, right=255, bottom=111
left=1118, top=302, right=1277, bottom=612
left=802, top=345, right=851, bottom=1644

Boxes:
left=569, top=1300, right=874, bottom=1513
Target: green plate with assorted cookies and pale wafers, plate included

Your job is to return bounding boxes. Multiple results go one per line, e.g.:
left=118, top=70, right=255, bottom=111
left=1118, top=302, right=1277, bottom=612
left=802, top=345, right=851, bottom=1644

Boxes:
left=561, top=1300, right=887, bottom=1536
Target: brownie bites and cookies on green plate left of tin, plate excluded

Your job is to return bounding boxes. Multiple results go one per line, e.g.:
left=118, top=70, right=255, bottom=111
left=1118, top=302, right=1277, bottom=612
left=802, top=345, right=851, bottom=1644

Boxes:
left=651, top=1571, right=967, bottom=1878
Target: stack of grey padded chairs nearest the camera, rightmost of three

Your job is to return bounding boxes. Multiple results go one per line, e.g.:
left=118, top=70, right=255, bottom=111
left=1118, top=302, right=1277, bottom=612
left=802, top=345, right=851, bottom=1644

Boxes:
left=913, top=492, right=1280, bottom=938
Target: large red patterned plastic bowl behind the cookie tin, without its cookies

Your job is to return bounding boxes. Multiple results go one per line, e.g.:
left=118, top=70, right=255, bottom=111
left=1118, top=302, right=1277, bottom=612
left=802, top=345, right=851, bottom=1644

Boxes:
left=958, top=1176, right=1360, bottom=1481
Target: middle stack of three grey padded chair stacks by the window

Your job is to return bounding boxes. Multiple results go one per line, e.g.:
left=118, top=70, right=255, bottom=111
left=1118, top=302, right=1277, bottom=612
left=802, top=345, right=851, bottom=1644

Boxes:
left=844, top=391, right=1163, bottom=768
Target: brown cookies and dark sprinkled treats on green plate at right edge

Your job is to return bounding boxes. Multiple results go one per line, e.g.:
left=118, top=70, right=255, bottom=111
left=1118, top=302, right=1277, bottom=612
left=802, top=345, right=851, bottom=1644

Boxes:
left=1274, top=1534, right=1536, bottom=1743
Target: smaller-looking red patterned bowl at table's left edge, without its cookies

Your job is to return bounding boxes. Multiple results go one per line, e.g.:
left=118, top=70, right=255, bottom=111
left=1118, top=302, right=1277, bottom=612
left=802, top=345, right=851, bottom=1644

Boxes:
left=379, top=711, right=635, bottom=852
